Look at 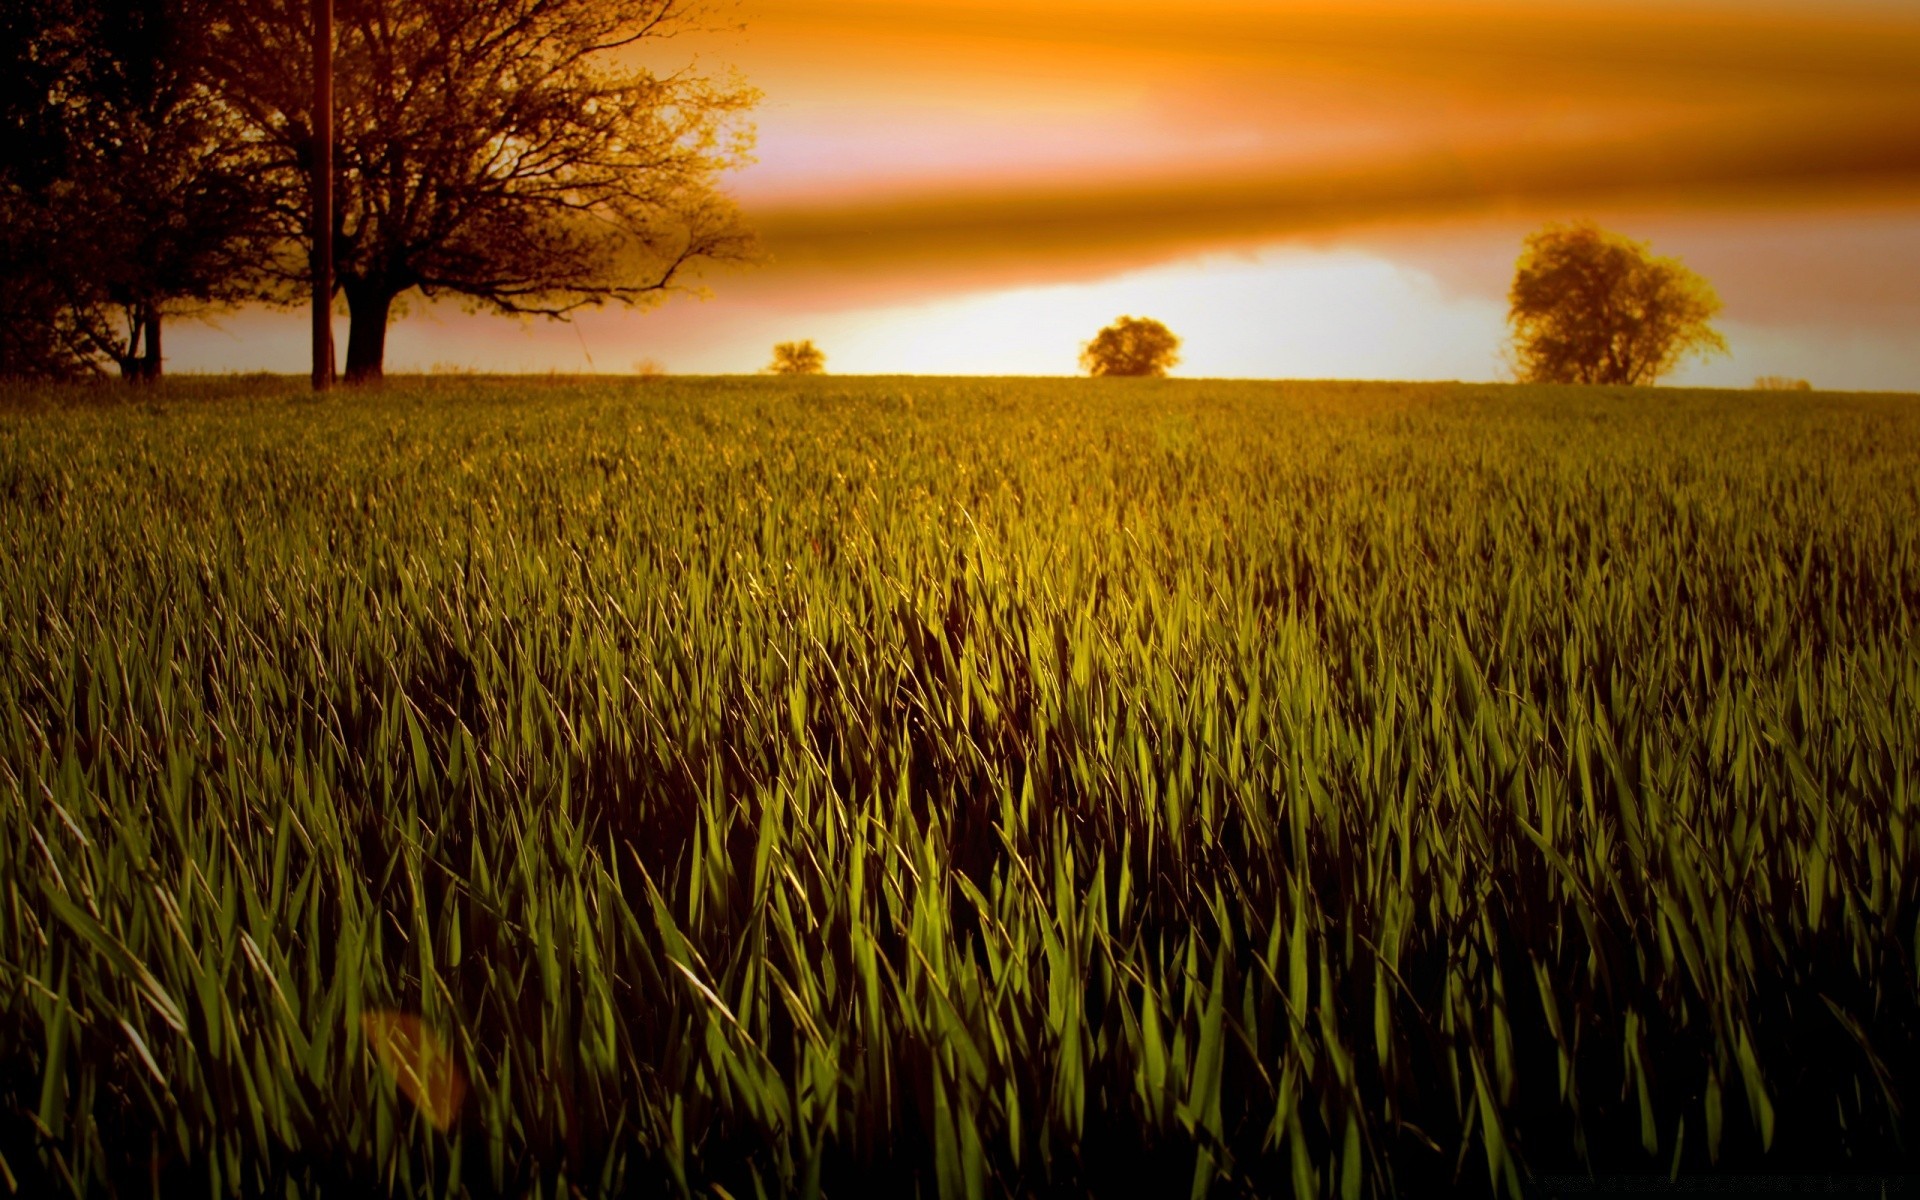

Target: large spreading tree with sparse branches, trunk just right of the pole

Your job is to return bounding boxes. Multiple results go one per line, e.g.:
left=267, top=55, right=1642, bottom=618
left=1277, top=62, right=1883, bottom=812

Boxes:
left=215, top=0, right=756, bottom=380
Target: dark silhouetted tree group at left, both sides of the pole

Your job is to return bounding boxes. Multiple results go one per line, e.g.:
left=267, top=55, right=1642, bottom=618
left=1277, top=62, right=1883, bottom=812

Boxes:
left=0, top=0, right=756, bottom=380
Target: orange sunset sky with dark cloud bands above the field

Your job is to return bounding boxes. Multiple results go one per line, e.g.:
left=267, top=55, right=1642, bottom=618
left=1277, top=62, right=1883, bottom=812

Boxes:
left=169, top=0, right=1920, bottom=390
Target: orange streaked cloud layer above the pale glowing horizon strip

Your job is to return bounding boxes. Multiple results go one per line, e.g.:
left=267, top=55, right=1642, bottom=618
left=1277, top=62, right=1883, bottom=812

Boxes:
left=729, top=0, right=1920, bottom=282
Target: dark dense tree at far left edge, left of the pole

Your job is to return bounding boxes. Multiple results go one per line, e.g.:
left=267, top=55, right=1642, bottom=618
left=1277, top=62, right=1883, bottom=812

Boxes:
left=0, top=0, right=271, bottom=378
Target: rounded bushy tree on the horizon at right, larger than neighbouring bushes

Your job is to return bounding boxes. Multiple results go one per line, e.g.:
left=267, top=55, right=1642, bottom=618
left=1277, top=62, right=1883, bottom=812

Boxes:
left=1507, top=223, right=1726, bottom=384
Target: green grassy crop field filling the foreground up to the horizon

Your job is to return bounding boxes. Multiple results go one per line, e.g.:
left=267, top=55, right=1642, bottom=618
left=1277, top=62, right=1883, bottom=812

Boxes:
left=0, top=376, right=1920, bottom=1198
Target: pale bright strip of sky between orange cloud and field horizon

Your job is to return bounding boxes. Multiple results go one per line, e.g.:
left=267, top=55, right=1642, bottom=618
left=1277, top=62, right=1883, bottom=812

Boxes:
left=173, top=215, right=1920, bottom=390
